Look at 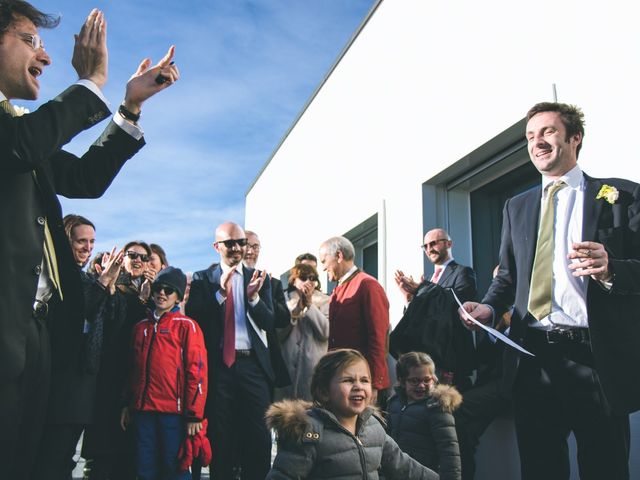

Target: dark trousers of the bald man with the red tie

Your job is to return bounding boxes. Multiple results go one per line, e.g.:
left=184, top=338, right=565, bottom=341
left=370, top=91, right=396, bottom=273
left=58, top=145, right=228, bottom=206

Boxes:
left=210, top=355, right=273, bottom=480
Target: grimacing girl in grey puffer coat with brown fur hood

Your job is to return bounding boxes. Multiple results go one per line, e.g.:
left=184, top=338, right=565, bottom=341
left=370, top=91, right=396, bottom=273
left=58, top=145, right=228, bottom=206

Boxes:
left=266, top=349, right=439, bottom=480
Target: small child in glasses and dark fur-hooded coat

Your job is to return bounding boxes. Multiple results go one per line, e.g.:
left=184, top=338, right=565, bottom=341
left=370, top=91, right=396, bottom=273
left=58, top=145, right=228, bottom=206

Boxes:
left=387, top=352, right=462, bottom=480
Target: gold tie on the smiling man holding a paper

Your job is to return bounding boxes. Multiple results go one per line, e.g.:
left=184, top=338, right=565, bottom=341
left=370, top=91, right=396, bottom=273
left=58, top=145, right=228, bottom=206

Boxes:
left=528, top=180, right=567, bottom=320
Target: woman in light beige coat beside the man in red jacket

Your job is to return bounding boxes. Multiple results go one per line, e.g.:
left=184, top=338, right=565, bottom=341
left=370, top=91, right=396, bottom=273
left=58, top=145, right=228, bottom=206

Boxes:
left=277, top=264, right=329, bottom=401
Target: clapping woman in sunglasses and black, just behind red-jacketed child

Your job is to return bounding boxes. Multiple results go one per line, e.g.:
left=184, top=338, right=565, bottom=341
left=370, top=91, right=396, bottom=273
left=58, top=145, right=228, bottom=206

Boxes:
left=82, top=240, right=157, bottom=480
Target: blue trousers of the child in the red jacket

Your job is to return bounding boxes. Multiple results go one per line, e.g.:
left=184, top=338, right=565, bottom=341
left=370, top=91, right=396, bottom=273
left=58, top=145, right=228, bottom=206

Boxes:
left=133, top=412, right=191, bottom=480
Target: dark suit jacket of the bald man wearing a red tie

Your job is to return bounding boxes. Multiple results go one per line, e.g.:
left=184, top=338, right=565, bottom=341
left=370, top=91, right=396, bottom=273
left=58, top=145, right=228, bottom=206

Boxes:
left=185, top=265, right=275, bottom=385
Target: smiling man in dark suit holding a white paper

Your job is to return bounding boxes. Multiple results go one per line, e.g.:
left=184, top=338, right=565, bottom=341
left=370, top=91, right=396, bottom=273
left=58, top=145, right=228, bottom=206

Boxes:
left=461, top=103, right=640, bottom=480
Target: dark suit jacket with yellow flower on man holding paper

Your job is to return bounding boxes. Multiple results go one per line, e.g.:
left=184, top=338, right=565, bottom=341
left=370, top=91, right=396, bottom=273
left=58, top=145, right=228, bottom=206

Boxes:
left=482, top=175, right=640, bottom=413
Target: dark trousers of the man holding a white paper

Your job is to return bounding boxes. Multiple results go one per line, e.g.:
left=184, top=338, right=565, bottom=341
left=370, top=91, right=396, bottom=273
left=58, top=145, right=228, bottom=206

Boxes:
left=514, top=341, right=629, bottom=480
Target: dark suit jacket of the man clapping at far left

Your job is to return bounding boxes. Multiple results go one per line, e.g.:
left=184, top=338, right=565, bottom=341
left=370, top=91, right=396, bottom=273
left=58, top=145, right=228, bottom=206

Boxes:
left=0, top=85, right=144, bottom=382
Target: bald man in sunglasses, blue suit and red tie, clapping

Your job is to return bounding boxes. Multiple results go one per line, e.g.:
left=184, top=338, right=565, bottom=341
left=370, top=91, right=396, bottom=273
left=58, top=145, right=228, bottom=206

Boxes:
left=186, top=222, right=275, bottom=480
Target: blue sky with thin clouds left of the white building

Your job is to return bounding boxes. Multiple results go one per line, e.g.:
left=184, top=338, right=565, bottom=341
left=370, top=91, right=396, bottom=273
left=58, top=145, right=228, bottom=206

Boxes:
left=25, top=0, right=374, bottom=271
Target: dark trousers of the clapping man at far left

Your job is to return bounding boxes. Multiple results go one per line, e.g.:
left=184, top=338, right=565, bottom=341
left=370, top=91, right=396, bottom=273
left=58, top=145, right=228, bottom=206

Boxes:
left=0, top=318, right=51, bottom=480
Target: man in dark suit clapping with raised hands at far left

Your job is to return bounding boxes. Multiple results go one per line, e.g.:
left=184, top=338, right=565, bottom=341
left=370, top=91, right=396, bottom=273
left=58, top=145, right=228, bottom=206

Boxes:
left=0, top=0, right=178, bottom=479
